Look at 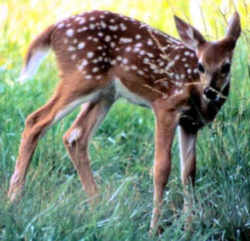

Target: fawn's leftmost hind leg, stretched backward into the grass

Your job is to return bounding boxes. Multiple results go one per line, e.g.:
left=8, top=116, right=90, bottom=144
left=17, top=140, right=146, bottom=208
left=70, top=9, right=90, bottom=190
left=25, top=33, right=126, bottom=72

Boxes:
left=8, top=80, right=101, bottom=201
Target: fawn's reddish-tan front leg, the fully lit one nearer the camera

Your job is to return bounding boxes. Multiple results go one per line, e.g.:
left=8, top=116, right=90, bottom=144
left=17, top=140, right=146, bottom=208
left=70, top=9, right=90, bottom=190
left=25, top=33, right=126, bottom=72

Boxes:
left=150, top=102, right=178, bottom=232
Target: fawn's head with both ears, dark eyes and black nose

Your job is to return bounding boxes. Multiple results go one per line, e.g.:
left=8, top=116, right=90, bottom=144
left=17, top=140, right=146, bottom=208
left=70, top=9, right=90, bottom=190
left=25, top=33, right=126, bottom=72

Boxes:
left=175, top=12, right=241, bottom=100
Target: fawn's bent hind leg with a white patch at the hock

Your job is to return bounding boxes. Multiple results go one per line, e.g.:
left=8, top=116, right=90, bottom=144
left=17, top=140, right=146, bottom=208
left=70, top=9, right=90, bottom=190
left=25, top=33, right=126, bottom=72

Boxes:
left=63, top=99, right=113, bottom=200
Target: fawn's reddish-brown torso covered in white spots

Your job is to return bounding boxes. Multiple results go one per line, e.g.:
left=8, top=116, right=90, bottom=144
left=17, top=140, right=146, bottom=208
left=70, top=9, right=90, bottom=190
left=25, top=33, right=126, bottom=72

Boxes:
left=24, top=11, right=199, bottom=105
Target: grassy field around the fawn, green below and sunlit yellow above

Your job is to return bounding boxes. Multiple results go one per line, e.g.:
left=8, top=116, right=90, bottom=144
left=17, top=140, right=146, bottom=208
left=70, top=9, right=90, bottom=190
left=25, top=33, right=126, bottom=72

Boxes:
left=0, top=0, right=250, bottom=241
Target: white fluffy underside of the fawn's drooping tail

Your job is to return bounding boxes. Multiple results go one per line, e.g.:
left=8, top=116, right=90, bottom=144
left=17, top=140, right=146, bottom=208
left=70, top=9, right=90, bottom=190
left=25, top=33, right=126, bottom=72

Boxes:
left=17, top=47, right=49, bottom=84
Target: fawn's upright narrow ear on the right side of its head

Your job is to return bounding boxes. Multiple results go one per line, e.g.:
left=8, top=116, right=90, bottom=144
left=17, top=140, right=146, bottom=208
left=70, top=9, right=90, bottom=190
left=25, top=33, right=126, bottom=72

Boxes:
left=226, top=12, right=241, bottom=42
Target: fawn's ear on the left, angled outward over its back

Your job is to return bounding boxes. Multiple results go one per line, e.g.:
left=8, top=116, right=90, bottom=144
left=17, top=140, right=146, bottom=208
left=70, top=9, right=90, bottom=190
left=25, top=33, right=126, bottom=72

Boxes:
left=174, top=16, right=206, bottom=50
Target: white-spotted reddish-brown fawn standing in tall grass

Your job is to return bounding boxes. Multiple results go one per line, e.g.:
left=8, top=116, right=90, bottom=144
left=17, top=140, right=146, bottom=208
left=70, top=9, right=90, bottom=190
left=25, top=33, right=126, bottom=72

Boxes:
left=8, top=11, right=241, bottom=232
